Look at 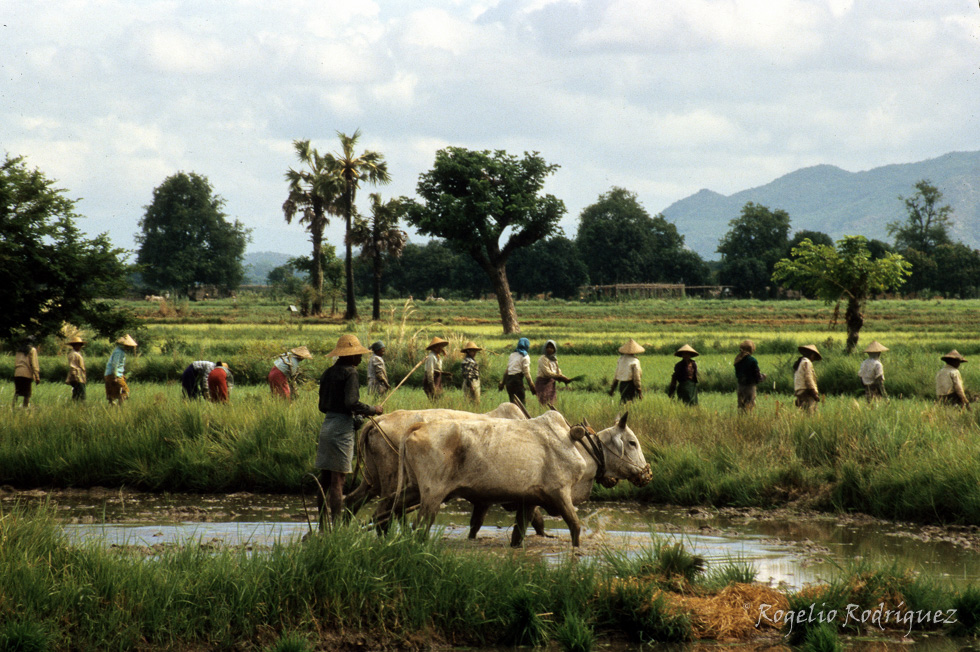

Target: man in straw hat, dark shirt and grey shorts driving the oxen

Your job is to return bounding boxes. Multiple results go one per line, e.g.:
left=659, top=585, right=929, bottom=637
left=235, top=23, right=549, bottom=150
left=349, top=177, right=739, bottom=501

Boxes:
left=316, top=335, right=384, bottom=531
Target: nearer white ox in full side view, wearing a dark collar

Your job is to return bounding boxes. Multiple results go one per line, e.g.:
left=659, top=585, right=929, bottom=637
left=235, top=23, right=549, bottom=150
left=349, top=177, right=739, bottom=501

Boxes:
left=395, top=411, right=651, bottom=546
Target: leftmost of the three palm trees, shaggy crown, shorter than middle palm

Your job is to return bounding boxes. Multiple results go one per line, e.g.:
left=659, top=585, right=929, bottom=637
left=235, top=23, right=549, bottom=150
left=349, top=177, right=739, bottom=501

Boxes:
left=282, top=140, right=342, bottom=315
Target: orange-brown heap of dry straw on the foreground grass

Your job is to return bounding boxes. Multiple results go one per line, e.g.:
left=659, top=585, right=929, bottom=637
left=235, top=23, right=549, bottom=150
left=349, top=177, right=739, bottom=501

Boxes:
left=665, top=584, right=789, bottom=640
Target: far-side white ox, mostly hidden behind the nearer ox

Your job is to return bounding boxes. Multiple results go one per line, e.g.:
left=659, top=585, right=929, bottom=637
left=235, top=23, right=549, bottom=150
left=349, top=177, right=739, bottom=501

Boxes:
left=345, top=403, right=544, bottom=539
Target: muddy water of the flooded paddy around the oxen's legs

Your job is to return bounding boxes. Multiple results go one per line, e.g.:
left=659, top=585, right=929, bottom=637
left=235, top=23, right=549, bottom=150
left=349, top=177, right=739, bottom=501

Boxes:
left=7, top=490, right=980, bottom=589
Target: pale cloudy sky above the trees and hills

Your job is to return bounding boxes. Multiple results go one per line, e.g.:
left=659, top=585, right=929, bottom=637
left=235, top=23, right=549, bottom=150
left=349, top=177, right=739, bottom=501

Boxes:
left=0, top=0, right=980, bottom=260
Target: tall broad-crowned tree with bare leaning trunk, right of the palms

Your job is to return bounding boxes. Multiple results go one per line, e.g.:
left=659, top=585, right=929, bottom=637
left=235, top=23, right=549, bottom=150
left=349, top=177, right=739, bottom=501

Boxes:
left=408, top=147, right=565, bottom=333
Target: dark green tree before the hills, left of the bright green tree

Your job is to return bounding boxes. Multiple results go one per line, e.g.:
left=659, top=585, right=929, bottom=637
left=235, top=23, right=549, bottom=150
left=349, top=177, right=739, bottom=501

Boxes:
left=718, top=202, right=790, bottom=297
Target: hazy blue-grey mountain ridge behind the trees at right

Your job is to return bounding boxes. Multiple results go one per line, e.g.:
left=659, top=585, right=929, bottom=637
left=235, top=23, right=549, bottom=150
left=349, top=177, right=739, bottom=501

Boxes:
left=663, top=152, right=980, bottom=260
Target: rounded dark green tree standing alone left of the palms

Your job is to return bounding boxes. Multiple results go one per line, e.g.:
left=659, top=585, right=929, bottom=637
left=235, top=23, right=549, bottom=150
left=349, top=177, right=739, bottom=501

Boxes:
left=136, top=172, right=251, bottom=294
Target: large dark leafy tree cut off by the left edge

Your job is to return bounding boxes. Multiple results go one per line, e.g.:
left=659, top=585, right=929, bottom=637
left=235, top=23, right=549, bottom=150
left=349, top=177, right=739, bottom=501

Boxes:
left=0, top=154, right=133, bottom=340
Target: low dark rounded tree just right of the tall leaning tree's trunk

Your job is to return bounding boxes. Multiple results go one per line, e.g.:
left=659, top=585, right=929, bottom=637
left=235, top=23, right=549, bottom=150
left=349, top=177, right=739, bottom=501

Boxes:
left=508, top=235, right=589, bottom=299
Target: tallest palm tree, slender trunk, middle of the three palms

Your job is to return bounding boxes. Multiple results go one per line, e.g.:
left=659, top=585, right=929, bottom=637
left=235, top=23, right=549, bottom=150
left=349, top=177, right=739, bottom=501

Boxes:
left=325, top=129, right=391, bottom=320
